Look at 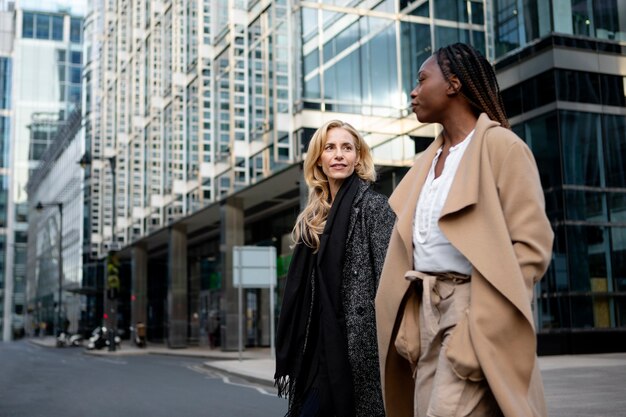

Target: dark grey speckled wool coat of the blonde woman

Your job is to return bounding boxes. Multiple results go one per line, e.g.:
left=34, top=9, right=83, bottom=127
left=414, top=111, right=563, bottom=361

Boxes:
left=341, top=179, right=396, bottom=417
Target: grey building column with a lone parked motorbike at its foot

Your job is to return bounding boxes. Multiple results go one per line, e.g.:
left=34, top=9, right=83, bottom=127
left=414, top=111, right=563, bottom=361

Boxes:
left=130, top=244, right=148, bottom=337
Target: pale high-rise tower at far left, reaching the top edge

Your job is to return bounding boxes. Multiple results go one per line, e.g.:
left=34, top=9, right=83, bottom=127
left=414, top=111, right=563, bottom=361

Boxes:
left=2, top=2, right=83, bottom=340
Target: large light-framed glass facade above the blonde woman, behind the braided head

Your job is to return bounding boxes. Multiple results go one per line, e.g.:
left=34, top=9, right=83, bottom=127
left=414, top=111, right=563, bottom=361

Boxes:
left=298, top=0, right=487, bottom=117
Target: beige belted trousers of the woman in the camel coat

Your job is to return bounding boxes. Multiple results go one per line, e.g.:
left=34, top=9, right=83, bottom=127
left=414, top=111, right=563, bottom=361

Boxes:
left=412, top=272, right=502, bottom=417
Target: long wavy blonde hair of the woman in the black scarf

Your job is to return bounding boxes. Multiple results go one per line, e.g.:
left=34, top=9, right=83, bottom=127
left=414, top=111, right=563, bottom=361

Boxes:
left=291, top=120, right=376, bottom=252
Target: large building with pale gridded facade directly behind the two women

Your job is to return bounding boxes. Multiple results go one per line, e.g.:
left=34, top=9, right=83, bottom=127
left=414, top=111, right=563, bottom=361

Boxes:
left=85, top=0, right=490, bottom=349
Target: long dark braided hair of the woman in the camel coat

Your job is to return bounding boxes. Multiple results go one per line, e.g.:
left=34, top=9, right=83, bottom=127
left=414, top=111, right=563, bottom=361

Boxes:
left=435, top=43, right=511, bottom=128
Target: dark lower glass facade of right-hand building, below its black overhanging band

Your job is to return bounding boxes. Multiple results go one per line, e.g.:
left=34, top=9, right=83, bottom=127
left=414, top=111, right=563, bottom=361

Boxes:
left=515, top=110, right=626, bottom=331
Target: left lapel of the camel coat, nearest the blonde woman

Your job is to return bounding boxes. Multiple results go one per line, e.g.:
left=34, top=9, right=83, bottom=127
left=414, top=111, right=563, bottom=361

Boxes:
left=389, top=135, right=443, bottom=264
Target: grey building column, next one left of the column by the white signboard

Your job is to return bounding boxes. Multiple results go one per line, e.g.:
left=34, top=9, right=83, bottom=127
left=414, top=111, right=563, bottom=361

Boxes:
left=167, top=225, right=188, bottom=348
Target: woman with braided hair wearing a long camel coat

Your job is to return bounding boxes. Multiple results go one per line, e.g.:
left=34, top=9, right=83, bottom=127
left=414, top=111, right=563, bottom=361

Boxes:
left=376, top=43, right=553, bottom=417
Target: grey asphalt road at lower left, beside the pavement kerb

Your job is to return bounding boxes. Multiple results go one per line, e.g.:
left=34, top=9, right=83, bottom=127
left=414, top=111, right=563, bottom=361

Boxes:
left=0, top=341, right=287, bottom=417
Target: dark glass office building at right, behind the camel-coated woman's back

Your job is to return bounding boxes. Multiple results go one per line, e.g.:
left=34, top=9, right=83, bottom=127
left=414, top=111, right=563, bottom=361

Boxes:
left=494, top=0, right=626, bottom=353
